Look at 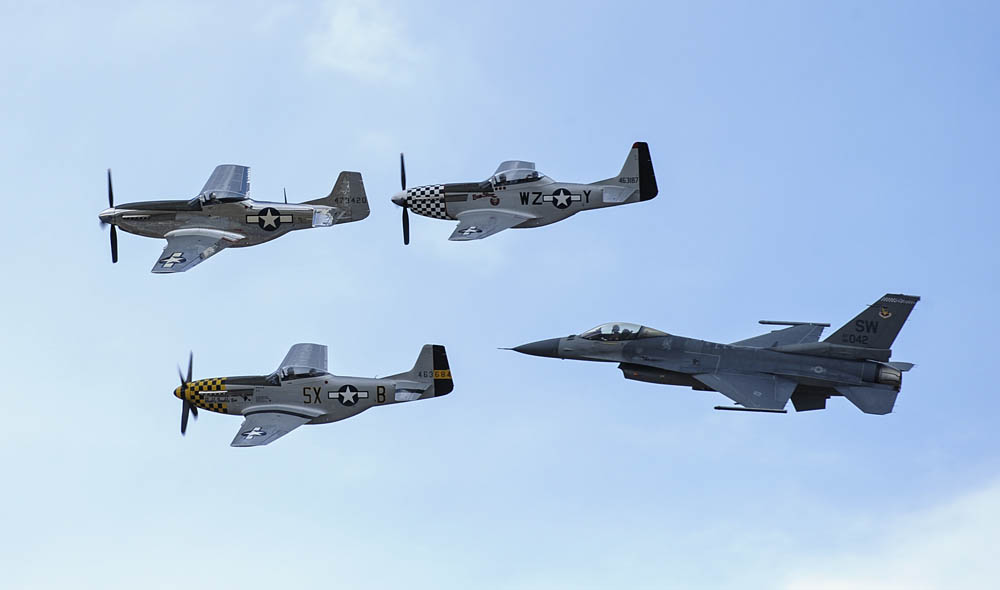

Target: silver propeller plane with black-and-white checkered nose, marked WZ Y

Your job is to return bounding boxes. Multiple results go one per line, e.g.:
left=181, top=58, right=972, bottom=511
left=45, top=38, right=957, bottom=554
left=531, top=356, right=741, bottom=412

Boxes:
left=392, top=142, right=657, bottom=244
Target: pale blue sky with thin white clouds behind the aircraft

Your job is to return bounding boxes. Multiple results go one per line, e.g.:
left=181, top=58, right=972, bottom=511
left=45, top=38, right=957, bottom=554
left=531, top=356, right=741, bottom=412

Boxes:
left=0, top=0, right=1000, bottom=590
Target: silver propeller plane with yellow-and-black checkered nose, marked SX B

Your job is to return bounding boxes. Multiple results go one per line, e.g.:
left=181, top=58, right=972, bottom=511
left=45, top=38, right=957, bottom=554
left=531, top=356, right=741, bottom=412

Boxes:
left=174, top=344, right=453, bottom=447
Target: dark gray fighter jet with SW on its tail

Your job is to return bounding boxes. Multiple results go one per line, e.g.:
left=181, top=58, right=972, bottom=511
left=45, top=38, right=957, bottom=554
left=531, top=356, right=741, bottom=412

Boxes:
left=513, top=294, right=920, bottom=414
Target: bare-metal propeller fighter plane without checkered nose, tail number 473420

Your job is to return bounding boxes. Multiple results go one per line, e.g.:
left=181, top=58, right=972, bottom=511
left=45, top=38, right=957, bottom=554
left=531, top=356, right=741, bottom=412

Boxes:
left=100, top=164, right=368, bottom=273
